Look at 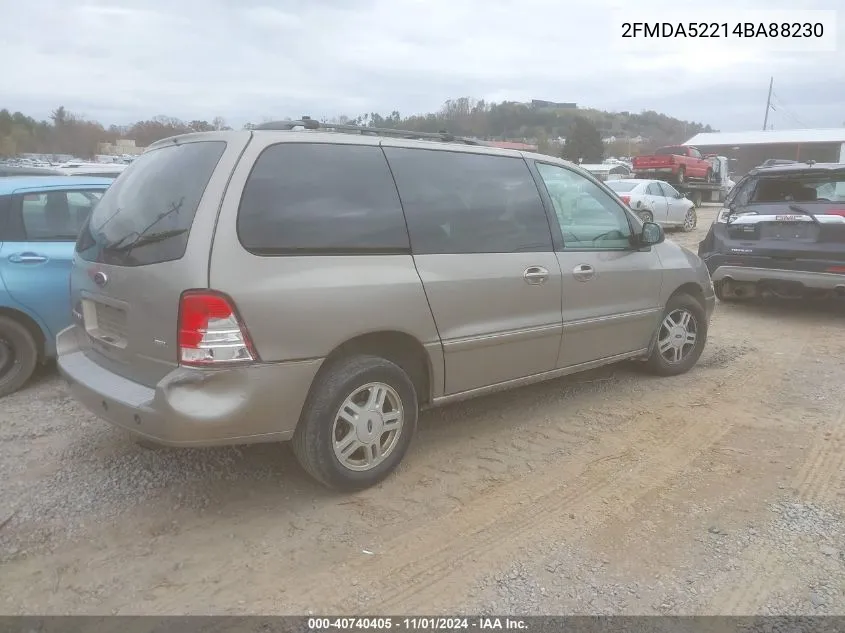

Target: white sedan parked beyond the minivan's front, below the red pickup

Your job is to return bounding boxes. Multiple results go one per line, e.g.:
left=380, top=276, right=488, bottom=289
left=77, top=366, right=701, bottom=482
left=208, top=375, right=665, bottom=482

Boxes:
left=605, top=178, right=698, bottom=231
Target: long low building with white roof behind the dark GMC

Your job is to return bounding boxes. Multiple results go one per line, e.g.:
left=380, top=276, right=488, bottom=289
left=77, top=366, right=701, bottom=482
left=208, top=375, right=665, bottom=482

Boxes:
left=684, top=127, right=845, bottom=180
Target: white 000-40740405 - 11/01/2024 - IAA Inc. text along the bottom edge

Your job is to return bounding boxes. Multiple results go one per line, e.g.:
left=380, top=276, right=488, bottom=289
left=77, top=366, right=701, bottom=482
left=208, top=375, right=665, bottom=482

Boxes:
left=307, top=616, right=528, bottom=631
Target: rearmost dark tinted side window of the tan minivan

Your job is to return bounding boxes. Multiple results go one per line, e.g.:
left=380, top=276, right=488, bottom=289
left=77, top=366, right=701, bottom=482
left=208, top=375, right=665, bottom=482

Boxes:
left=237, top=143, right=410, bottom=256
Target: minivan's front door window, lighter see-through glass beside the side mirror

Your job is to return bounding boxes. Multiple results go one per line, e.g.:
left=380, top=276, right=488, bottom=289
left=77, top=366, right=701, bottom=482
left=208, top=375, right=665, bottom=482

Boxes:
left=536, top=163, right=632, bottom=250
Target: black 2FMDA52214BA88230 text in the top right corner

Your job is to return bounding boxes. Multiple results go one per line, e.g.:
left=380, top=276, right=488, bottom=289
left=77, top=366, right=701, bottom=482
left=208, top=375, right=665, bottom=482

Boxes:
left=622, top=22, right=824, bottom=39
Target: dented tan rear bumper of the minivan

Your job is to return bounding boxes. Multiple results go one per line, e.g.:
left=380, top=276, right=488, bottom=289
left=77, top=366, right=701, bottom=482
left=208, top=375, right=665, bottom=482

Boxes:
left=56, top=325, right=322, bottom=446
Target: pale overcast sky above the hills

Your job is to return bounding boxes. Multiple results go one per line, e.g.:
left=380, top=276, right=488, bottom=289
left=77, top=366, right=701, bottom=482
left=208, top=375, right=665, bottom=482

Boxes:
left=0, top=0, right=845, bottom=131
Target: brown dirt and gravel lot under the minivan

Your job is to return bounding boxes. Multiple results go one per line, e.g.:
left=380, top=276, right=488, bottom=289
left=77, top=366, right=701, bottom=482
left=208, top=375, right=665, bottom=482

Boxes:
left=0, top=209, right=845, bottom=614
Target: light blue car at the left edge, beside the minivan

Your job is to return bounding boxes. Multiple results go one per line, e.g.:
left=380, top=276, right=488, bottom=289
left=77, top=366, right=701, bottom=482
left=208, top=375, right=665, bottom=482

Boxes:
left=0, top=176, right=114, bottom=397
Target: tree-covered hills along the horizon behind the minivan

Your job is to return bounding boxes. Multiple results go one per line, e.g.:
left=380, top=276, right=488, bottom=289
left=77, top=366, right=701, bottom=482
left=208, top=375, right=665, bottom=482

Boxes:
left=0, top=97, right=714, bottom=162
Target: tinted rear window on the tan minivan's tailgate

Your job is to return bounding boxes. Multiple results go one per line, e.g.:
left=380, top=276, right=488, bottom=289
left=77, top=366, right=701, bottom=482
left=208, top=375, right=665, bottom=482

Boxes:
left=76, top=141, right=226, bottom=266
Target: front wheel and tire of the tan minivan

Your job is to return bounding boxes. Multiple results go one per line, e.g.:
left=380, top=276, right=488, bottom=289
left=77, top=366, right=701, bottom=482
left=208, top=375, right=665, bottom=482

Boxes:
left=646, top=294, right=708, bottom=376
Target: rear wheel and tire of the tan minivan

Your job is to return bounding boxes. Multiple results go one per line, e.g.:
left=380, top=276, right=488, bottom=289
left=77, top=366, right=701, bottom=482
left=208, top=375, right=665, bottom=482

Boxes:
left=292, top=355, right=419, bottom=491
